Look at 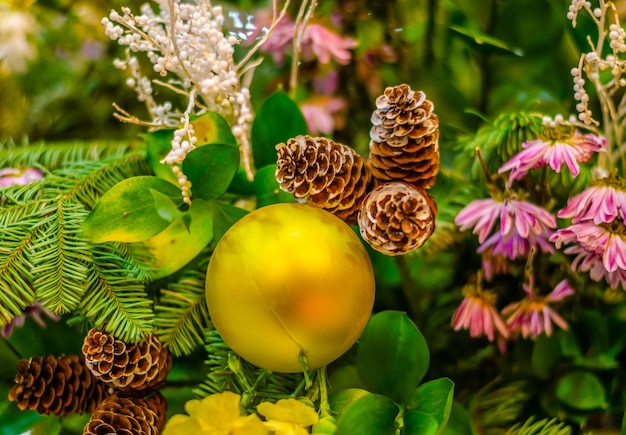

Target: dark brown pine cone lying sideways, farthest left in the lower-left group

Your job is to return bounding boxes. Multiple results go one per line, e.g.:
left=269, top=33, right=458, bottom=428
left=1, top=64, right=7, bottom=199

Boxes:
left=9, top=355, right=106, bottom=417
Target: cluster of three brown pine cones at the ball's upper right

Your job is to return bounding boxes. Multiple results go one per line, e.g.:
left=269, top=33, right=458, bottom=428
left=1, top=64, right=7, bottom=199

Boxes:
left=276, top=84, right=439, bottom=255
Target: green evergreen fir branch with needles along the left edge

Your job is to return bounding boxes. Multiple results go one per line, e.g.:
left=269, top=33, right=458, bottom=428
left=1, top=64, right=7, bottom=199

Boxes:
left=0, top=142, right=153, bottom=342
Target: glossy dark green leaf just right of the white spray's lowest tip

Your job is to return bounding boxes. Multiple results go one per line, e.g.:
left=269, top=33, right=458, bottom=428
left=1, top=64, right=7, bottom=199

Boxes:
left=183, top=143, right=239, bottom=200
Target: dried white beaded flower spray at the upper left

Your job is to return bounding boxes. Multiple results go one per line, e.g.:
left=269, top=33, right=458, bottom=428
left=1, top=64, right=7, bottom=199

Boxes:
left=102, top=0, right=288, bottom=203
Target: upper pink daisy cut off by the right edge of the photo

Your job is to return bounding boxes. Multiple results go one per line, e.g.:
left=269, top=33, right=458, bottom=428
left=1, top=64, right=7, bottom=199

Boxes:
left=557, top=184, right=626, bottom=224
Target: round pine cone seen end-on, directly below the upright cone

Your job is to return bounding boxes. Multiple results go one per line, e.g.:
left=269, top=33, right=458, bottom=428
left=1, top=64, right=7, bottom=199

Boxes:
left=359, top=183, right=437, bottom=255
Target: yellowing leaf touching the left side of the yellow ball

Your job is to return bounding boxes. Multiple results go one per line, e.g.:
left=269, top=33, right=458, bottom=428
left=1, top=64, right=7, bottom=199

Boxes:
left=143, top=199, right=215, bottom=279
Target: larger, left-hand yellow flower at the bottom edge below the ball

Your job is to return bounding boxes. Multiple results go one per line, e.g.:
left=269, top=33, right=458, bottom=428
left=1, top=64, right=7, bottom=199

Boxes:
left=163, top=391, right=271, bottom=435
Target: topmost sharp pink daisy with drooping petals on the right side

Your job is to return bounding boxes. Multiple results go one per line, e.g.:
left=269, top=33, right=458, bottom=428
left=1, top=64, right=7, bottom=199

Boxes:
left=498, top=132, right=607, bottom=185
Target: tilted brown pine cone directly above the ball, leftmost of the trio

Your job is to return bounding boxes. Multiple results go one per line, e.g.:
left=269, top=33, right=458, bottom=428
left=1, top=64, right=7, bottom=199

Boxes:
left=276, top=136, right=370, bottom=223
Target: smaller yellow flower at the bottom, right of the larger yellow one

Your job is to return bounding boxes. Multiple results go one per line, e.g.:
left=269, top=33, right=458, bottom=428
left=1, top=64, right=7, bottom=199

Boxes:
left=256, top=399, right=319, bottom=435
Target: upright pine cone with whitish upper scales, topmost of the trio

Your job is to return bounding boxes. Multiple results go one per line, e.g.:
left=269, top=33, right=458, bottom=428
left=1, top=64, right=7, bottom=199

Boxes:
left=370, top=84, right=439, bottom=189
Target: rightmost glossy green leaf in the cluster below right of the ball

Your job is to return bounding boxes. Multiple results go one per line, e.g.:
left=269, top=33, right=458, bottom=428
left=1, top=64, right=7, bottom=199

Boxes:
left=406, top=378, right=454, bottom=434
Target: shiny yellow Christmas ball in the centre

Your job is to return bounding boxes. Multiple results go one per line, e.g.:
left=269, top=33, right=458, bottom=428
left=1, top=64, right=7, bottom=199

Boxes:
left=206, top=204, right=375, bottom=373
